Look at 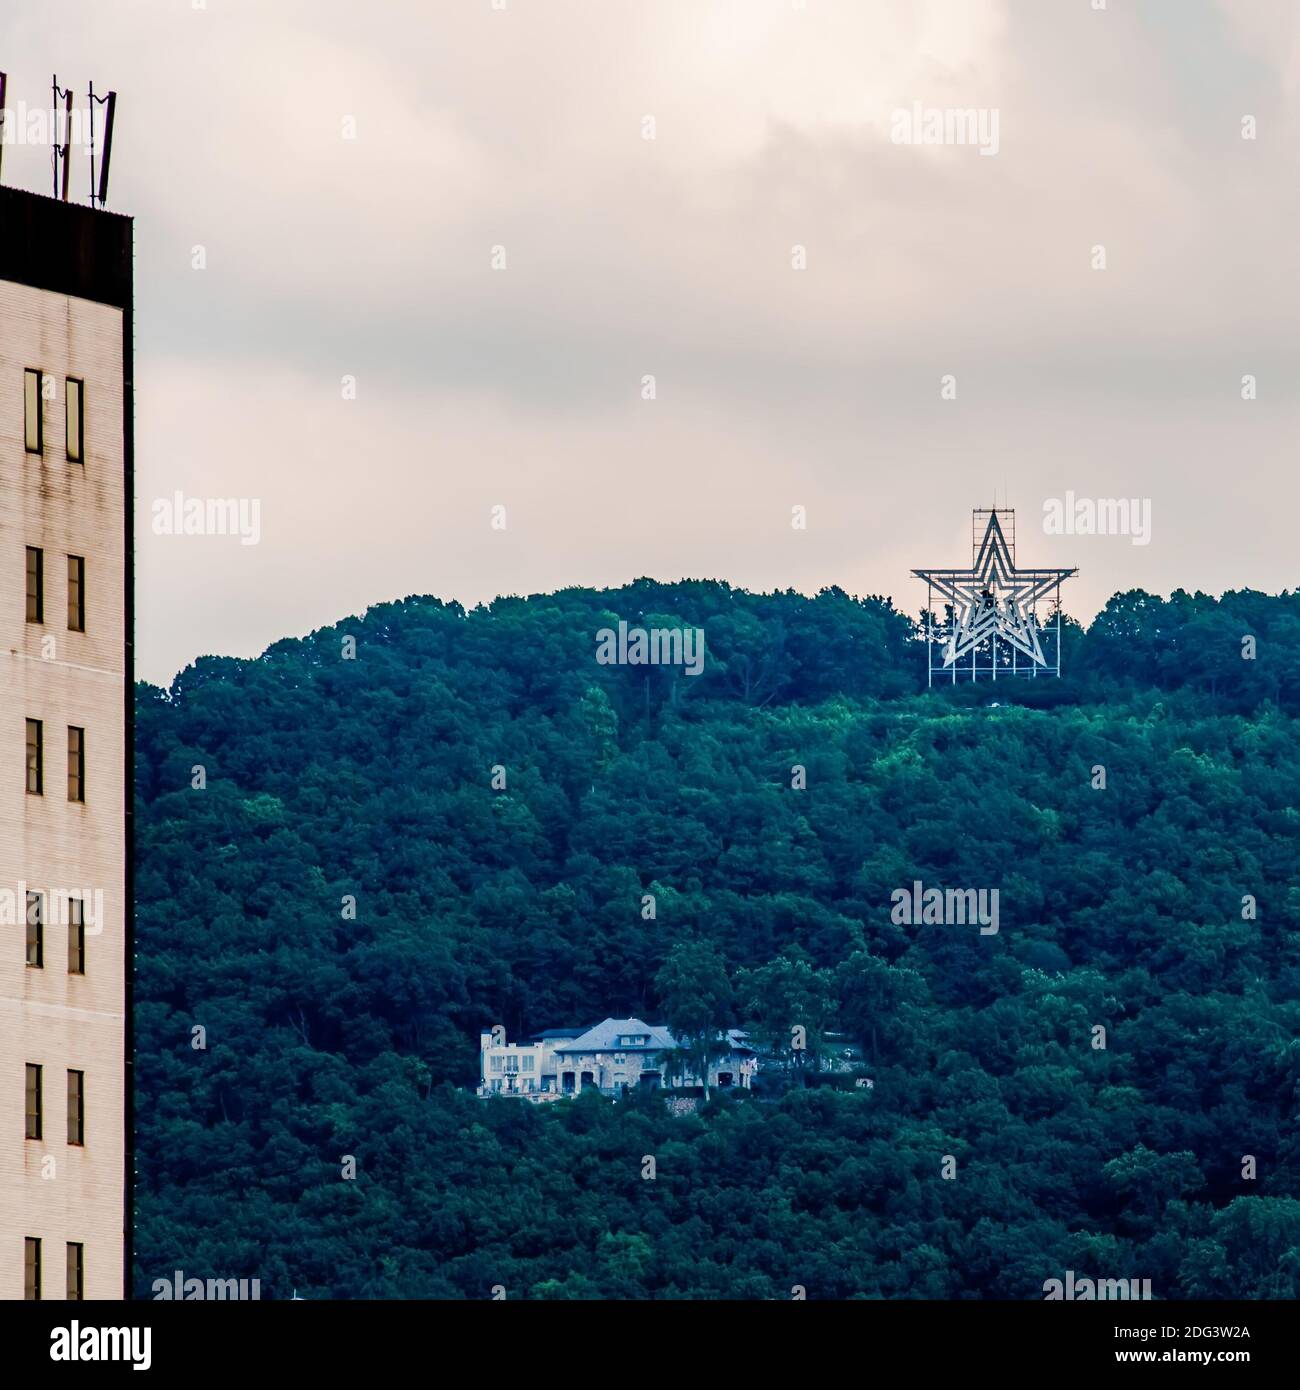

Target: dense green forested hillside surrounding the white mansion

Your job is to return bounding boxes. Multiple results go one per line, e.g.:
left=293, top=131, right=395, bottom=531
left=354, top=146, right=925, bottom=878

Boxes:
left=135, top=581, right=1300, bottom=1298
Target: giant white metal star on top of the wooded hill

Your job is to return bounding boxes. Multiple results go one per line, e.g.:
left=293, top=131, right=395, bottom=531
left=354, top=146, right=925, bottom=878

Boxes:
left=912, top=512, right=1079, bottom=666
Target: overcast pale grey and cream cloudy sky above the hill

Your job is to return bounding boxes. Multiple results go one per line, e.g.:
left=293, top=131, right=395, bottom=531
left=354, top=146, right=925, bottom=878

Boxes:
left=0, top=0, right=1300, bottom=684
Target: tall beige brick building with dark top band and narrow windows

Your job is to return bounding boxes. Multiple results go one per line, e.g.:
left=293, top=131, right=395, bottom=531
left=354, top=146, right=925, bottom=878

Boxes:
left=0, top=188, right=132, bottom=1298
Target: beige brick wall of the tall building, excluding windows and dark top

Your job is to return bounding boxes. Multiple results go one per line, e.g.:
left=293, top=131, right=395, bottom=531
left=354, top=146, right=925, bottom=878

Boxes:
left=0, top=281, right=125, bottom=1298
